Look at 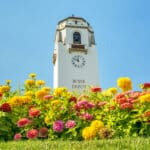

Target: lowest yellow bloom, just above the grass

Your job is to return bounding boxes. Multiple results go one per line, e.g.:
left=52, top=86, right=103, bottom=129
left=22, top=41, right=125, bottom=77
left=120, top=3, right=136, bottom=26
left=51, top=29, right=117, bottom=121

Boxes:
left=82, top=127, right=96, bottom=140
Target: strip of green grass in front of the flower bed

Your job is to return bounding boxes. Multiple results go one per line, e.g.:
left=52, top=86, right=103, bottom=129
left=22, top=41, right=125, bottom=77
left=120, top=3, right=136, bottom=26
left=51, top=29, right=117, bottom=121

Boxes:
left=0, top=138, right=150, bottom=150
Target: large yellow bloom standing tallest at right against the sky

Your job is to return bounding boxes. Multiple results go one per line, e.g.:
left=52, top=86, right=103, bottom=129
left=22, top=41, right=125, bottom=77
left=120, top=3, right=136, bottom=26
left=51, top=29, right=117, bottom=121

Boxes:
left=117, top=77, right=132, bottom=92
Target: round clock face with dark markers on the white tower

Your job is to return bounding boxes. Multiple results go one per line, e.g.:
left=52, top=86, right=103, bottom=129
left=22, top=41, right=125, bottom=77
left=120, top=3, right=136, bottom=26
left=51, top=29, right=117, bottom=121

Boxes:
left=71, top=55, right=86, bottom=68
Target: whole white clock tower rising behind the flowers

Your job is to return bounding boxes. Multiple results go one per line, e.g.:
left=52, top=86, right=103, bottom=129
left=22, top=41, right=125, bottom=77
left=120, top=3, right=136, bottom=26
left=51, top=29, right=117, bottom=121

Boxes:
left=53, top=16, right=99, bottom=91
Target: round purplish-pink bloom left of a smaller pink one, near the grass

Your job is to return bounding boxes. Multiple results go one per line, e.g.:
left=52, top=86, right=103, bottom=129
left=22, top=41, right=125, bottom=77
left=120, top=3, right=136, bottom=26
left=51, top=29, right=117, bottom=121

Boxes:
left=53, top=120, right=64, bottom=132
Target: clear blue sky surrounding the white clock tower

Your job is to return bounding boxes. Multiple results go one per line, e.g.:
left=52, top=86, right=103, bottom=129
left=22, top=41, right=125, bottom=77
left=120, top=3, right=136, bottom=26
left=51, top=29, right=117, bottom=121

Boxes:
left=0, top=0, right=150, bottom=90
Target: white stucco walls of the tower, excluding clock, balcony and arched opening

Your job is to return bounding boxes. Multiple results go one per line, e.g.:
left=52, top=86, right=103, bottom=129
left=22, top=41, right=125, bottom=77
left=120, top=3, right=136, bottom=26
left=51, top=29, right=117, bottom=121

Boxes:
left=54, top=17, right=100, bottom=90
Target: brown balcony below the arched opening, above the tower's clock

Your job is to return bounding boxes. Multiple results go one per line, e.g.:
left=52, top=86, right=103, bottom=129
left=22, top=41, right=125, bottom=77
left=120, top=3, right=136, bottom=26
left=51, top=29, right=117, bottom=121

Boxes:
left=69, top=44, right=87, bottom=54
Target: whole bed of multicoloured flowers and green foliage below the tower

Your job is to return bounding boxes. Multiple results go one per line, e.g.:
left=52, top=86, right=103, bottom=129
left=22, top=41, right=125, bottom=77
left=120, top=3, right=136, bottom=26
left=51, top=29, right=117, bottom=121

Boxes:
left=0, top=73, right=150, bottom=140
